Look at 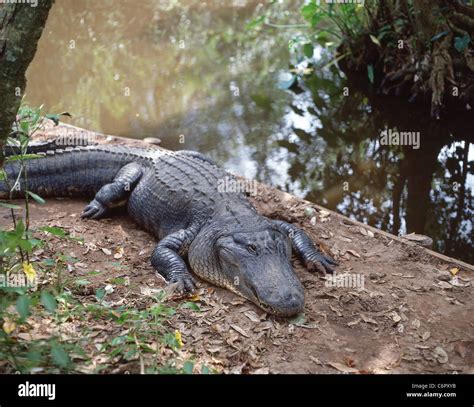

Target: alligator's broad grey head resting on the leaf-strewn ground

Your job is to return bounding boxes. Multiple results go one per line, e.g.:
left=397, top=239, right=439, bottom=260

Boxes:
left=189, top=219, right=304, bottom=317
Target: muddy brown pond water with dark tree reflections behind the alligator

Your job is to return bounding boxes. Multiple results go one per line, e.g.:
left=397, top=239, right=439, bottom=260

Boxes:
left=26, top=0, right=474, bottom=263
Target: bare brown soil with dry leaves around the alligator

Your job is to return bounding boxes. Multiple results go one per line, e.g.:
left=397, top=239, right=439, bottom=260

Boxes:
left=1, top=125, right=474, bottom=373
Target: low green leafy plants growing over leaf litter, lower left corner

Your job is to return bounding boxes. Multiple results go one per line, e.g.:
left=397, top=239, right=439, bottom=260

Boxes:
left=0, top=106, right=210, bottom=373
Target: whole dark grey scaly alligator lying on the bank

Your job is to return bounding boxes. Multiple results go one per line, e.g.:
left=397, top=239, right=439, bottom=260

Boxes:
left=0, top=146, right=336, bottom=316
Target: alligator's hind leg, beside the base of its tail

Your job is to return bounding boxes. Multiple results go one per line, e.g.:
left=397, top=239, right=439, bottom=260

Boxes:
left=81, top=163, right=143, bottom=219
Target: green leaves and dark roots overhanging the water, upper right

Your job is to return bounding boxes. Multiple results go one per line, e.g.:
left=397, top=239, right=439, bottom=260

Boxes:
left=249, top=0, right=474, bottom=118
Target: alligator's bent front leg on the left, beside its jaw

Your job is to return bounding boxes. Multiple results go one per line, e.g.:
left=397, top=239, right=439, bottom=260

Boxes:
left=151, top=228, right=196, bottom=292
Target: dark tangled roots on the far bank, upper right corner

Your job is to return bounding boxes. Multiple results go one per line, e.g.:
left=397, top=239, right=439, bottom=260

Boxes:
left=339, top=0, right=474, bottom=119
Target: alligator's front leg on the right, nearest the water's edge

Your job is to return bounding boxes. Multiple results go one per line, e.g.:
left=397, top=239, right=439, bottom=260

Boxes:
left=273, top=220, right=337, bottom=273
